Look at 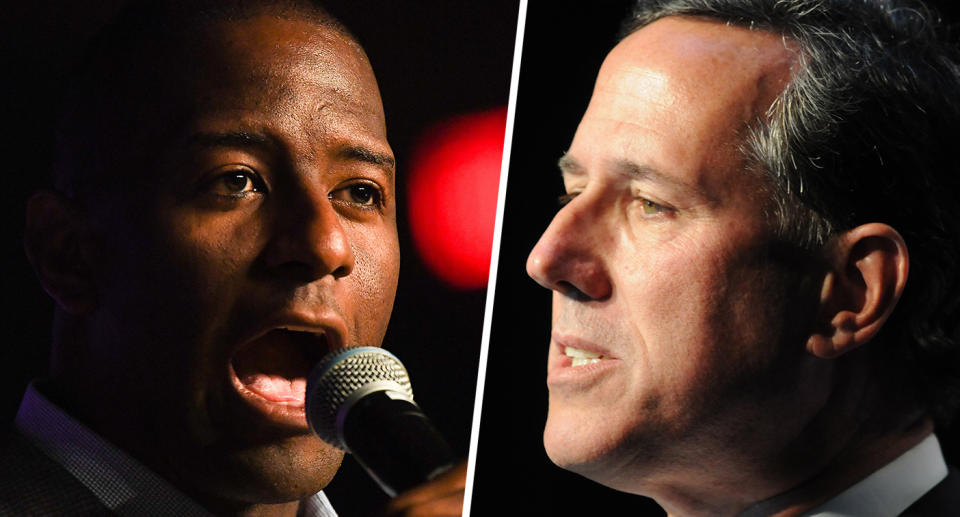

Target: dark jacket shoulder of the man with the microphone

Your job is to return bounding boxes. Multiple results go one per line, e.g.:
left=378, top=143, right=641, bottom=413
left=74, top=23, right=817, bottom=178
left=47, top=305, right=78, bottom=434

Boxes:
left=0, top=429, right=113, bottom=517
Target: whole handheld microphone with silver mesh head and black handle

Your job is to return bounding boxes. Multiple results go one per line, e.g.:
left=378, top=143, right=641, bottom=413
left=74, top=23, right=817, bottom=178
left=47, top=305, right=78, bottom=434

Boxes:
left=306, top=347, right=454, bottom=497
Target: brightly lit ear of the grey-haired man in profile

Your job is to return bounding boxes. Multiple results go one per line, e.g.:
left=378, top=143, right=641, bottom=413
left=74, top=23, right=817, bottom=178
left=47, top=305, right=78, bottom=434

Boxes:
left=807, top=223, right=910, bottom=358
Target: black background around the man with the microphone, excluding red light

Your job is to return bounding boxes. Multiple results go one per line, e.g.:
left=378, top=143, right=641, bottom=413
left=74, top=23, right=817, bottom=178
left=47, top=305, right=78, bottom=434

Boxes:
left=0, top=0, right=519, bottom=517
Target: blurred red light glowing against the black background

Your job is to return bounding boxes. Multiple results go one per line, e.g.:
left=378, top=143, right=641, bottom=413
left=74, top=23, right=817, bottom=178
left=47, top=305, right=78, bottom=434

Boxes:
left=407, top=108, right=507, bottom=289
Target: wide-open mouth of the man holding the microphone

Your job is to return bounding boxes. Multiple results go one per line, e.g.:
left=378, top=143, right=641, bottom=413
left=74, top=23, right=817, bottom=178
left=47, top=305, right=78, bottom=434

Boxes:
left=230, top=328, right=329, bottom=408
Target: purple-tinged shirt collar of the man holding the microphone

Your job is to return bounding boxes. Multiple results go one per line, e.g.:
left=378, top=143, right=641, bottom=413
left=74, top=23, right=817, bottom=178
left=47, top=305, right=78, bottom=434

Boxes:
left=14, top=383, right=337, bottom=517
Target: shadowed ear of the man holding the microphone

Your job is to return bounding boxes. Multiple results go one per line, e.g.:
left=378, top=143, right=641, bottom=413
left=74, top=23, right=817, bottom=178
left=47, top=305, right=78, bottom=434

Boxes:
left=23, top=190, right=96, bottom=316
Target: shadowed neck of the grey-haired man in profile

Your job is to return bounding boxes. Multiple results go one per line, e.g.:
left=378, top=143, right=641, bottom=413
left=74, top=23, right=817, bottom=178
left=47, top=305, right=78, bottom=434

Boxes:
left=644, top=352, right=933, bottom=517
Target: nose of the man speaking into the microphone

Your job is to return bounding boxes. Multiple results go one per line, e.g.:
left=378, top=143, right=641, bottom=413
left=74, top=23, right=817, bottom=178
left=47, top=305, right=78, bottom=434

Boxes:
left=265, top=189, right=355, bottom=281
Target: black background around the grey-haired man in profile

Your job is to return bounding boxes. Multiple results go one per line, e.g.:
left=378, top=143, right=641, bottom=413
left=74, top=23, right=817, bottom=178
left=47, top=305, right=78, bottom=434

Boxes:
left=471, top=0, right=960, bottom=517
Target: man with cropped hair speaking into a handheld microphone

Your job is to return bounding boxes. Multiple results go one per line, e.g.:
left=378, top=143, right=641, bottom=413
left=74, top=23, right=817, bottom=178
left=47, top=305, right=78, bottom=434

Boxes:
left=0, top=1, right=480, bottom=516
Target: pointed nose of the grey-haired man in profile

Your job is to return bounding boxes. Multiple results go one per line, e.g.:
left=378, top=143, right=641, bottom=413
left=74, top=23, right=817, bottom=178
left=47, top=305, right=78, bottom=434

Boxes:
left=527, top=198, right=613, bottom=300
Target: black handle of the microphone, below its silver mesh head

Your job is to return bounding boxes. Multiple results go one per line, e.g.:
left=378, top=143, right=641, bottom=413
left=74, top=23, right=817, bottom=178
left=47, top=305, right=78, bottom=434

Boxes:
left=341, top=391, right=454, bottom=497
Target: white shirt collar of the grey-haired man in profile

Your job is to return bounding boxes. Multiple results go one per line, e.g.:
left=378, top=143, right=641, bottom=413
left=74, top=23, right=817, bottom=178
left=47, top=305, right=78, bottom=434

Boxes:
left=803, top=434, right=947, bottom=517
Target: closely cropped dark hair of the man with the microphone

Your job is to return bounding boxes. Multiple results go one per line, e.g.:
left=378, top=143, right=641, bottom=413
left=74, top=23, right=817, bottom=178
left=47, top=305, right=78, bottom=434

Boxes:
left=53, top=0, right=363, bottom=198
